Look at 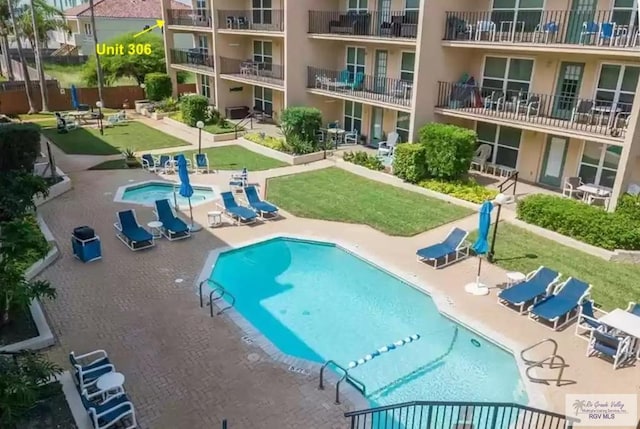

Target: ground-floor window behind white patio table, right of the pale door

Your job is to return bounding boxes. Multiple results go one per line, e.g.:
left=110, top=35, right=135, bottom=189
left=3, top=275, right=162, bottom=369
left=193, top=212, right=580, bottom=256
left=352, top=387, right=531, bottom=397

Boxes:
left=578, top=142, right=622, bottom=188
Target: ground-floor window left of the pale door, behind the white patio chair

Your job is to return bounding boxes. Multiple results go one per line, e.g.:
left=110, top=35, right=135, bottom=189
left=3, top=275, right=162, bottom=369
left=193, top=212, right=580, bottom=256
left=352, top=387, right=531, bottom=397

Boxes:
left=476, top=122, right=522, bottom=168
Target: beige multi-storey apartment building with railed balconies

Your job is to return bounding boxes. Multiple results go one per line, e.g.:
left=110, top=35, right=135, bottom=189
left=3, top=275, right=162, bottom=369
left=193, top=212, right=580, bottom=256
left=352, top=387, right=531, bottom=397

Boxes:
left=163, top=0, right=640, bottom=209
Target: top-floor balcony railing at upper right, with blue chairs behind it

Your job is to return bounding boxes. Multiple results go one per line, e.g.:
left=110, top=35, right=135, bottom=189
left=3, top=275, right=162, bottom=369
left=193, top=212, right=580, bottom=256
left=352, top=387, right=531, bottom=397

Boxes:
left=444, top=10, right=640, bottom=48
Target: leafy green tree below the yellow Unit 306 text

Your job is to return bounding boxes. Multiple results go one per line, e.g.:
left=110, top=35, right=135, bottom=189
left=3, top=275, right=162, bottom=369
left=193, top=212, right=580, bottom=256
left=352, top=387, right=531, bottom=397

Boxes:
left=84, top=33, right=167, bottom=85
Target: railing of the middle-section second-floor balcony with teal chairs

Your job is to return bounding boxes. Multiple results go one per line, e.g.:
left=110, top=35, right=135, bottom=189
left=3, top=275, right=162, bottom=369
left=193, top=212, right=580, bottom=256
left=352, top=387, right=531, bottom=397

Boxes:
left=307, top=67, right=413, bottom=106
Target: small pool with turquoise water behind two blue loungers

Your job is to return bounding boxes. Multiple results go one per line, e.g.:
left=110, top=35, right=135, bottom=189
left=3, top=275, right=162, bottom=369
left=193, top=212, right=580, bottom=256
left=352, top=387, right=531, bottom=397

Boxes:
left=114, top=181, right=217, bottom=208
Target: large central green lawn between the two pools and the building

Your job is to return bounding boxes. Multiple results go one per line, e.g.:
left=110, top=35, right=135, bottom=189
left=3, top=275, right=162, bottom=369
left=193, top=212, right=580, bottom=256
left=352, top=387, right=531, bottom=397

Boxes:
left=267, top=167, right=473, bottom=236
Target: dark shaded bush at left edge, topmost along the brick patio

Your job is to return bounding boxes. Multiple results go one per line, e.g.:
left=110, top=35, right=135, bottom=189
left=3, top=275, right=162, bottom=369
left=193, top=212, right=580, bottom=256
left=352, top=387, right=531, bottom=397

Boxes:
left=0, top=124, right=40, bottom=173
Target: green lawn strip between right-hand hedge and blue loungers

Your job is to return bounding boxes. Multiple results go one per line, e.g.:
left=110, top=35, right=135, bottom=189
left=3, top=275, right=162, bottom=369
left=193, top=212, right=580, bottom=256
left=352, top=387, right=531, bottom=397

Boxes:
left=469, top=222, right=640, bottom=310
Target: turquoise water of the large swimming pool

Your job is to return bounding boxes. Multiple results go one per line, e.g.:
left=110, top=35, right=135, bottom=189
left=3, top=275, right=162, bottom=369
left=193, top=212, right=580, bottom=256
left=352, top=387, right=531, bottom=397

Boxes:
left=210, top=238, right=528, bottom=405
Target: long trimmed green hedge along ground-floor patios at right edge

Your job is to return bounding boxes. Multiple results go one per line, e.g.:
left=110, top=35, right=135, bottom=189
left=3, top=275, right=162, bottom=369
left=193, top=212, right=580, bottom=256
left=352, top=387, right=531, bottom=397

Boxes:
left=517, top=194, right=640, bottom=250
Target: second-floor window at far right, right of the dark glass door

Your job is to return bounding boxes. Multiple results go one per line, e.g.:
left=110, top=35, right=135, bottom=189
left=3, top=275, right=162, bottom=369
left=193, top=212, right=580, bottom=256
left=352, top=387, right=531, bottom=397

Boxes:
left=596, top=64, right=640, bottom=112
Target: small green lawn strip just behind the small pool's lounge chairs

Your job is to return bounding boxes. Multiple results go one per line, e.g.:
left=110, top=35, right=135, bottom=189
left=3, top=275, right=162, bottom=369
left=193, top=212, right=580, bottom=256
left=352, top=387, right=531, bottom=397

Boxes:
left=173, top=145, right=288, bottom=172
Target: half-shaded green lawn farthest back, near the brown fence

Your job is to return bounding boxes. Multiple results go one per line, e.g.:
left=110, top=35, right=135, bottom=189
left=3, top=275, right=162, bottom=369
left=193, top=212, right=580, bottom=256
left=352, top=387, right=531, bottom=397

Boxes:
left=42, top=121, right=188, bottom=155
